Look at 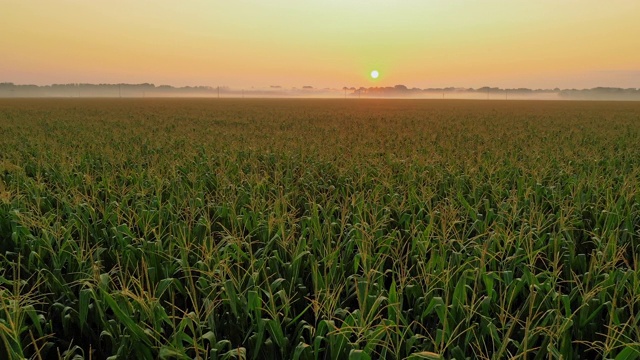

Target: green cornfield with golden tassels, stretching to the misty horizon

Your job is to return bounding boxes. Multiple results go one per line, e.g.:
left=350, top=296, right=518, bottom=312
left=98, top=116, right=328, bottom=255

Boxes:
left=0, top=99, right=640, bottom=360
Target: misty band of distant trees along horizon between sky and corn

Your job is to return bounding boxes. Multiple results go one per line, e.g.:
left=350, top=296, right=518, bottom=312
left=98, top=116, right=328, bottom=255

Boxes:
left=0, top=82, right=640, bottom=100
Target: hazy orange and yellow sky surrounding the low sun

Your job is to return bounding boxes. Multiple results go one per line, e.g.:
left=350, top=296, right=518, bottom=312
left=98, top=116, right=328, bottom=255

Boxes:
left=0, top=0, right=640, bottom=88
